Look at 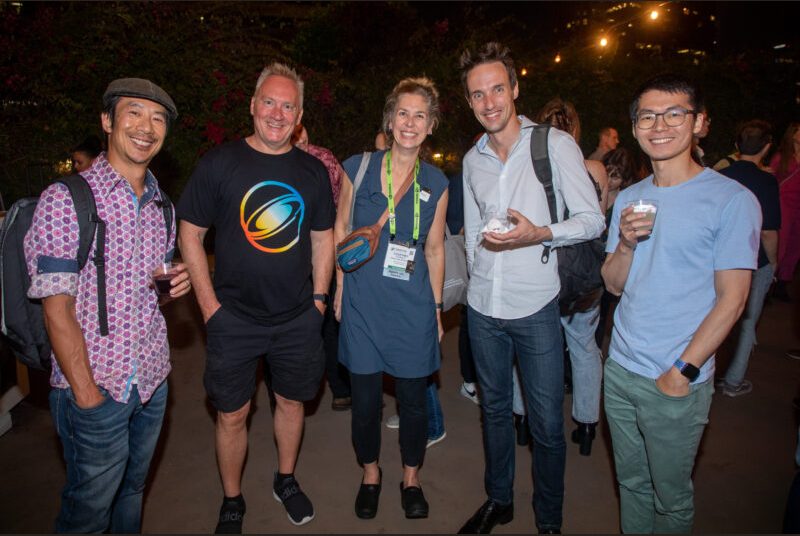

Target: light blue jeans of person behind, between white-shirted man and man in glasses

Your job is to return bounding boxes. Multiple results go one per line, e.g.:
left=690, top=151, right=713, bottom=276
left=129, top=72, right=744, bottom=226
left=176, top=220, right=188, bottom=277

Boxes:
left=561, top=304, right=603, bottom=423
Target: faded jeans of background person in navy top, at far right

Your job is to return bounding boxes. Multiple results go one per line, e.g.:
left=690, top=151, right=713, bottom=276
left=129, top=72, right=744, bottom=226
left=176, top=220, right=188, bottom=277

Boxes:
left=725, top=264, right=774, bottom=387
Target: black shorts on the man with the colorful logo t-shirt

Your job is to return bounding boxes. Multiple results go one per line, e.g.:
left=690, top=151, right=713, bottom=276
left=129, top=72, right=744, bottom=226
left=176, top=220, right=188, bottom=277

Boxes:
left=203, top=306, right=325, bottom=413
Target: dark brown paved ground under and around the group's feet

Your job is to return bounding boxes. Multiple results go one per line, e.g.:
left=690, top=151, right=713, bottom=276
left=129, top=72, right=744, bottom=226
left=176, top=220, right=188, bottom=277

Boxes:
left=0, top=283, right=800, bottom=533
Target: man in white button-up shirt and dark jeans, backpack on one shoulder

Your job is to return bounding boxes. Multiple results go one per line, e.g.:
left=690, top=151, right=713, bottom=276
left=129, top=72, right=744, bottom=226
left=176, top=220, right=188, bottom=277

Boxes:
left=461, top=43, right=605, bottom=533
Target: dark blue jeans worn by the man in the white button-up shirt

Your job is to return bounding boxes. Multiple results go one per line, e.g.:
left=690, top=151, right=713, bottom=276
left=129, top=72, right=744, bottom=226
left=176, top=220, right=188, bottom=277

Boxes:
left=468, top=300, right=566, bottom=530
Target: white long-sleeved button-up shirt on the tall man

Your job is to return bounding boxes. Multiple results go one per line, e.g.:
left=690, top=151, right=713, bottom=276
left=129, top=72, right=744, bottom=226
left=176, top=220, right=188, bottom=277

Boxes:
left=464, top=116, right=605, bottom=320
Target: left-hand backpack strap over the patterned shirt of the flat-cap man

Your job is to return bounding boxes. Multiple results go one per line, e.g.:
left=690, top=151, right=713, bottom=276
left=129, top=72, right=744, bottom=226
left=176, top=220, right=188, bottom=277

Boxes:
left=53, top=174, right=108, bottom=337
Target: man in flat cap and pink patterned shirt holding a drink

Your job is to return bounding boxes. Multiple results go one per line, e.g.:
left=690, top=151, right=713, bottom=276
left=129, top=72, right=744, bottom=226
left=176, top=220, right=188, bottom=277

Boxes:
left=25, top=78, right=191, bottom=533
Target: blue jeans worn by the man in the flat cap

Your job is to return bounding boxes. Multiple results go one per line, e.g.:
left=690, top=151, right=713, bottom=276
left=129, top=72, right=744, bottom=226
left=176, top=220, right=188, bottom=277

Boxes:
left=50, top=381, right=167, bottom=533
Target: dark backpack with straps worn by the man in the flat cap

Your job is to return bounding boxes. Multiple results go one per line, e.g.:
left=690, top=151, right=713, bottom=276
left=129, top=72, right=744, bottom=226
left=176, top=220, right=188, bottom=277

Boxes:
left=0, top=175, right=172, bottom=370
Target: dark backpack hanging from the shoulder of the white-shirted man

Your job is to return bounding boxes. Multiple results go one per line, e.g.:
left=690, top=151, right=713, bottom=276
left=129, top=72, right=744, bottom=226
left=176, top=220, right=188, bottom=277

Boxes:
left=531, top=124, right=605, bottom=316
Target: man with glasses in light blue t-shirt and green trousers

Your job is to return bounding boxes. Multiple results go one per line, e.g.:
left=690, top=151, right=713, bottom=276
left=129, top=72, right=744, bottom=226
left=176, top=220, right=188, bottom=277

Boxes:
left=603, top=75, right=761, bottom=533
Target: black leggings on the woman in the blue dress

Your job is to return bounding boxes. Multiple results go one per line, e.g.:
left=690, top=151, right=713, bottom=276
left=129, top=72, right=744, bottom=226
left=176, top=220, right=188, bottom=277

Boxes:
left=350, top=372, right=428, bottom=467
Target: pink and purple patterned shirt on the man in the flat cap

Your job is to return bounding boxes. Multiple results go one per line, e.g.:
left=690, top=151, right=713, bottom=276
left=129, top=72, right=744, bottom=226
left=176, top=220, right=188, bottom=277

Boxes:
left=25, top=153, right=175, bottom=403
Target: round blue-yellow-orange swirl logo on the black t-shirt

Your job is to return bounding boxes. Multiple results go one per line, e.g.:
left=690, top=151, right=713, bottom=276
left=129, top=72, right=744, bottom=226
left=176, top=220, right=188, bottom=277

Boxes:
left=239, top=181, right=306, bottom=253
